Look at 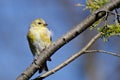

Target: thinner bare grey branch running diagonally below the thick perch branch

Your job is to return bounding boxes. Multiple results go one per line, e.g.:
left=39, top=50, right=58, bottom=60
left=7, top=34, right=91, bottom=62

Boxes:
left=34, top=33, right=101, bottom=80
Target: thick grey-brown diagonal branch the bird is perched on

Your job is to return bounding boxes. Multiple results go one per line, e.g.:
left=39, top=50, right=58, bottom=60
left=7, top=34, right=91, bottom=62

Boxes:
left=17, top=0, right=120, bottom=80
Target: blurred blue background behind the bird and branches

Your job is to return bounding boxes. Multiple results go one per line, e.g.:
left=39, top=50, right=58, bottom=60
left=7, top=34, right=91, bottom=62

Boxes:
left=0, top=0, right=120, bottom=80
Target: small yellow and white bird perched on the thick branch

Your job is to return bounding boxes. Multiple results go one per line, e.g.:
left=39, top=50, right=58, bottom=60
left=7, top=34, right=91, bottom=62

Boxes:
left=27, top=18, right=51, bottom=73
